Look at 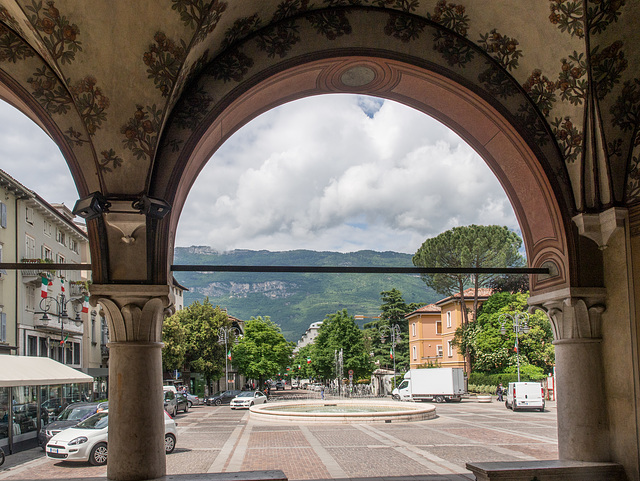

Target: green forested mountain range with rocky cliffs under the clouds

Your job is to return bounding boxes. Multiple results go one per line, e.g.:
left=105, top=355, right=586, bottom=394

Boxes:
left=173, top=246, right=442, bottom=341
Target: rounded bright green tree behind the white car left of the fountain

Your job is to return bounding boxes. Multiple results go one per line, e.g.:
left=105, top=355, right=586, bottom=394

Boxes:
left=232, top=316, right=294, bottom=386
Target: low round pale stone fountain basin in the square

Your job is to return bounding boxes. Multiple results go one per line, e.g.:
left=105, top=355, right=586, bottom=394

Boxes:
left=250, top=400, right=436, bottom=424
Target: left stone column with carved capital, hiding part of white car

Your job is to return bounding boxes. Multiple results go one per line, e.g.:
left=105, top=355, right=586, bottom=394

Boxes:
left=90, top=284, right=172, bottom=481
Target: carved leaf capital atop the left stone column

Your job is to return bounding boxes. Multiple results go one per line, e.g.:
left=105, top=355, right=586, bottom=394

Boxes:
left=89, top=284, right=173, bottom=342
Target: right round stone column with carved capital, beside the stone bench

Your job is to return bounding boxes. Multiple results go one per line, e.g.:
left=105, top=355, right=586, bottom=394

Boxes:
left=529, top=288, right=610, bottom=461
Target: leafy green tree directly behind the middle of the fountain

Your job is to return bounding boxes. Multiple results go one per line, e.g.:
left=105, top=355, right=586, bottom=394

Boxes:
left=312, top=309, right=373, bottom=379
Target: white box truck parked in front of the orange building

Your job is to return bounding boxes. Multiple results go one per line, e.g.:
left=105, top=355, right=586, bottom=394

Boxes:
left=391, top=367, right=465, bottom=402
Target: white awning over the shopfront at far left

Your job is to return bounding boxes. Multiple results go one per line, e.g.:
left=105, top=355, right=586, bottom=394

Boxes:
left=0, top=354, right=93, bottom=387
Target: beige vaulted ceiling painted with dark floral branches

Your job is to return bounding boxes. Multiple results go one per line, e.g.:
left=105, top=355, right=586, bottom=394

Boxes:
left=0, top=0, right=640, bottom=284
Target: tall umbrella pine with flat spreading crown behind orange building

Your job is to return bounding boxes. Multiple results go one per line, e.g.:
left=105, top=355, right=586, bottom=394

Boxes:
left=413, top=225, right=524, bottom=372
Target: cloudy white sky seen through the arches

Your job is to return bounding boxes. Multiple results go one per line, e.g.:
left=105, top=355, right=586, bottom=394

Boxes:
left=0, top=91, right=518, bottom=254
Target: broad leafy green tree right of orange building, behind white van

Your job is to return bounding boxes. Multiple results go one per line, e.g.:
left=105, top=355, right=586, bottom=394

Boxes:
left=455, top=292, right=555, bottom=374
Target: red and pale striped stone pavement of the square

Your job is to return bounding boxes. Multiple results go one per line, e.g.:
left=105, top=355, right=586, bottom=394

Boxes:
left=0, top=400, right=558, bottom=481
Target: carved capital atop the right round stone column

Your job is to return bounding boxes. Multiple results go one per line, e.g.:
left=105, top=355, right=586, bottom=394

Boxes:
left=529, top=288, right=606, bottom=341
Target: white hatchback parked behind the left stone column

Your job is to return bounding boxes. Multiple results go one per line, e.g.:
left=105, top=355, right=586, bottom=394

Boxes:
left=46, top=411, right=177, bottom=466
